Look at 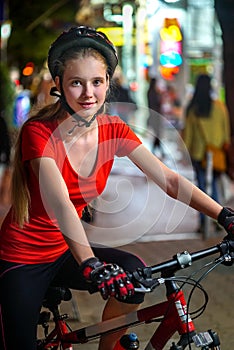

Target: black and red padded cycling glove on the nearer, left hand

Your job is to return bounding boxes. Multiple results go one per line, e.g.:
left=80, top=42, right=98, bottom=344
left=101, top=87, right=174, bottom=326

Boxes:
left=80, top=258, right=134, bottom=300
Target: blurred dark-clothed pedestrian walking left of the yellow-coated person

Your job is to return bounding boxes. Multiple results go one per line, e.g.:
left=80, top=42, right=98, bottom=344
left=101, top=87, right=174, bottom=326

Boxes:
left=147, top=78, right=163, bottom=153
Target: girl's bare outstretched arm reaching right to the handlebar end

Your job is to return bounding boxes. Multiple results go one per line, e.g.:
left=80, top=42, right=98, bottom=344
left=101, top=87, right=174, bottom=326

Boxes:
left=129, top=145, right=222, bottom=219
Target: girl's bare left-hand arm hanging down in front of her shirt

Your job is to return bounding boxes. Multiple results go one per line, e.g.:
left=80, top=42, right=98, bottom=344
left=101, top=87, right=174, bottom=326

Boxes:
left=31, top=158, right=94, bottom=264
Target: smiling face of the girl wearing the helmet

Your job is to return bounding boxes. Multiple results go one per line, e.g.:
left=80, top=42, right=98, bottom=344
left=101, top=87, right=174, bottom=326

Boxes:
left=55, top=56, right=109, bottom=118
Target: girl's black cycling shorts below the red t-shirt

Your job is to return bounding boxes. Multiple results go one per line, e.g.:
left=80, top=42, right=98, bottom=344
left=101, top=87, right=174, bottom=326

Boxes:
left=0, top=248, right=145, bottom=350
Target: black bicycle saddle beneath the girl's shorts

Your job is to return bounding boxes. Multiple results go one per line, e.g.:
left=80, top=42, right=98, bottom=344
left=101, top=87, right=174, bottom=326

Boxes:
left=42, top=287, right=72, bottom=309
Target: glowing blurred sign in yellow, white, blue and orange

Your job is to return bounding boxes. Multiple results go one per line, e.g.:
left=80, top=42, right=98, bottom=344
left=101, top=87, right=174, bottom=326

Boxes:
left=159, top=18, right=183, bottom=80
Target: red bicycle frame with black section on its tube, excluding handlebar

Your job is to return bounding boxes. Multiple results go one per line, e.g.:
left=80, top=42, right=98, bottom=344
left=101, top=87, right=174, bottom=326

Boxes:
left=44, top=281, right=195, bottom=350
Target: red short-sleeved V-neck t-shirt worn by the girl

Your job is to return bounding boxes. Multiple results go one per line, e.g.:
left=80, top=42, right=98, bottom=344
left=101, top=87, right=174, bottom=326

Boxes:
left=0, top=115, right=141, bottom=264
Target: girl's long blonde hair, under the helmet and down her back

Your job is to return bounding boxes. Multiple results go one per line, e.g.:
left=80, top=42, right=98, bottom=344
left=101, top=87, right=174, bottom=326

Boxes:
left=11, top=48, right=107, bottom=227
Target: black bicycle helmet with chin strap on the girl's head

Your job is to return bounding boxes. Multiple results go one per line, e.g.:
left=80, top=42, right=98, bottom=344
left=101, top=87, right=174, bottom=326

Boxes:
left=48, top=26, right=118, bottom=127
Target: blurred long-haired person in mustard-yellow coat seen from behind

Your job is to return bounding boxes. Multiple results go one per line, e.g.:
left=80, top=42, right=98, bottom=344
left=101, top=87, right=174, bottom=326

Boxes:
left=183, top=74, right=230, bottom=232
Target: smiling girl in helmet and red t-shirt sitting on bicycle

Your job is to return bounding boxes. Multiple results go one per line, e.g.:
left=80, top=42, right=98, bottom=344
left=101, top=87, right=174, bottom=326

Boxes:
left=0, top=26, right=234, bottom=350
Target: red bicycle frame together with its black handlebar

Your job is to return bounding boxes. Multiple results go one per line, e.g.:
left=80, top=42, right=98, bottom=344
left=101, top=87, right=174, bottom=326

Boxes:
left=38, top=241, right=233, bottom=350
